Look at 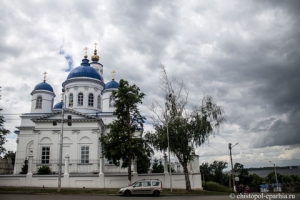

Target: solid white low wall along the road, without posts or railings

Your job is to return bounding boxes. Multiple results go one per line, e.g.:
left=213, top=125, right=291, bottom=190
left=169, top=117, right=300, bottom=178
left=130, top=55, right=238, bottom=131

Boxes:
left=0, top=174, right=202, bottom=189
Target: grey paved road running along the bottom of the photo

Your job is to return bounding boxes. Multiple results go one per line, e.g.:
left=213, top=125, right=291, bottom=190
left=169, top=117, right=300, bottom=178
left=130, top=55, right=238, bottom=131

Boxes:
left=0, top=194, right=300, bottom=200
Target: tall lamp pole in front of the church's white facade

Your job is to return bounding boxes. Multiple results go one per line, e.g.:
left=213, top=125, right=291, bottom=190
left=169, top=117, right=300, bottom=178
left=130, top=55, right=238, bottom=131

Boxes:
left=57, top=91, right=64, bottom=192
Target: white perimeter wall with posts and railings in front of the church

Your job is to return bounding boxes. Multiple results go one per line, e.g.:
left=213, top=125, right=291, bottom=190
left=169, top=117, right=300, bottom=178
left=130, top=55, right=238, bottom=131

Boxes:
left=0, top=155, right=202, bottom=189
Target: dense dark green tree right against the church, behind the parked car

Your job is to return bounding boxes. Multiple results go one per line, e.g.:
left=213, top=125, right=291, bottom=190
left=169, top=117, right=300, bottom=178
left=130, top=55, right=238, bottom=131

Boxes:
left=100, top=79, right=153, bottom=183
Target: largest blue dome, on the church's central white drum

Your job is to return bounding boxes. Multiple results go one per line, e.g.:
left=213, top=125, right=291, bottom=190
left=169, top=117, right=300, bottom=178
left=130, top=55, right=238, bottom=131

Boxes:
left=67, top=59, right=102, bottom=81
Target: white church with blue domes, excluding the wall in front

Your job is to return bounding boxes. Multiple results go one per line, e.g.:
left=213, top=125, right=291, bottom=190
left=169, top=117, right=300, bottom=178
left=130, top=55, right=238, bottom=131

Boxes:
left=14, top=47, right=126, bottom=174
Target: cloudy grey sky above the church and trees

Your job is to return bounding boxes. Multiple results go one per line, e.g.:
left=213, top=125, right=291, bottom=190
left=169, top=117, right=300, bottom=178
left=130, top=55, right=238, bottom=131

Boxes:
left=0, top=0, right=300, bottom=167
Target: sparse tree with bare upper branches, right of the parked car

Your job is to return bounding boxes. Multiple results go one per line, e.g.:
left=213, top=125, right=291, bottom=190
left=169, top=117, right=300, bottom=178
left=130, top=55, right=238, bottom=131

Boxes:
left=146, top=66, right=224, bottom=190
